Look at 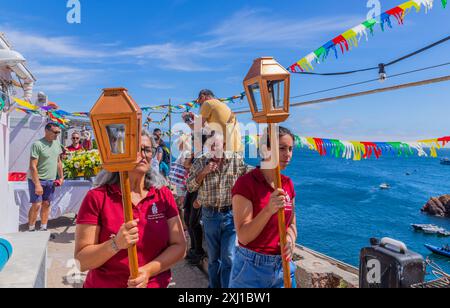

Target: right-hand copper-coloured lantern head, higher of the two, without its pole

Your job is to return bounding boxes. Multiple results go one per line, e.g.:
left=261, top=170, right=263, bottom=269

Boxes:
left=244, top=57, right=290, bottom=123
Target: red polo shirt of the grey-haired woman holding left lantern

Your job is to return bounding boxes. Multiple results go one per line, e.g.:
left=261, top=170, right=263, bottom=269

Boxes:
left=77, top=185, right=178, bottom=288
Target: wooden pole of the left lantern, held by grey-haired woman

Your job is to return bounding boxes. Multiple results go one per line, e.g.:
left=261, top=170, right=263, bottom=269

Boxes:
left=120, top=171, right=139, bottom=279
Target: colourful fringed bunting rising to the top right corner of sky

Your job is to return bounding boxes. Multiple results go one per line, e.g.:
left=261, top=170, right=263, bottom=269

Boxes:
left=288, top=0, right=447, bottom=73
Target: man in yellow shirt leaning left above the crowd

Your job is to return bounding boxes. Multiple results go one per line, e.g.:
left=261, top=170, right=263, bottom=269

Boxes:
left=183, top=89, right=243, bottom=152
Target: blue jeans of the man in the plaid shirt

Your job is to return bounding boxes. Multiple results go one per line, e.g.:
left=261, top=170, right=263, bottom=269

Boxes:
left=202, top=207, right=236, bottom=289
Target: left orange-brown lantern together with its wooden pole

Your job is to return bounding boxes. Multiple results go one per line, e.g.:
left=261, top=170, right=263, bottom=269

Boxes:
left=90, top=88, right=142, bottom=278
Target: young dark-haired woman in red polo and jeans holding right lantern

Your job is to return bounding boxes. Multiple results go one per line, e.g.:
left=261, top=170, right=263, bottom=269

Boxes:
left=230, top=127, right=297, bottom=288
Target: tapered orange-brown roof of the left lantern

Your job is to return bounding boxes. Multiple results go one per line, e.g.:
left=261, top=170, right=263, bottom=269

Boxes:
left=91, top=88, right=142, bottom=115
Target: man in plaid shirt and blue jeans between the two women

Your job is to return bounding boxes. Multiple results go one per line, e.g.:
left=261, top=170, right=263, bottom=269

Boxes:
left=187, top=131, right=253, bottom=288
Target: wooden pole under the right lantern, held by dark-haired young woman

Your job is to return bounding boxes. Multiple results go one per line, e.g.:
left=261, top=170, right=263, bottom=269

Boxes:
left=269, top=124, right=292, bottom=289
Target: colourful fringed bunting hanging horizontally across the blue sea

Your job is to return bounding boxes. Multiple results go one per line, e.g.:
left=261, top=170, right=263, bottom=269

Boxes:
left=244, top=135, right=450, bottom=161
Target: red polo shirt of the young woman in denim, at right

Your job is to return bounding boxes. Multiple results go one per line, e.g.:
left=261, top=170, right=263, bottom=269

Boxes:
left=232, top=168, right=295, bottom=255
